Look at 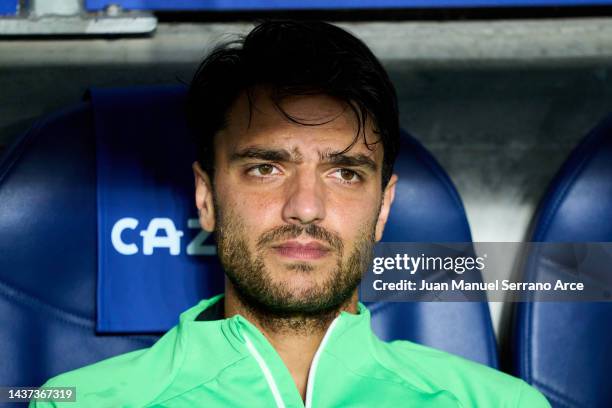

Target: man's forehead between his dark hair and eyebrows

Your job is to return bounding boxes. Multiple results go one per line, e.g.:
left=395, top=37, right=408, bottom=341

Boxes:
left=215, top=88, right=383, bottom=159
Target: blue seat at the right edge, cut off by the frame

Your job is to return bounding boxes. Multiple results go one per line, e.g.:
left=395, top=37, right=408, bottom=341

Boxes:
left=512, top=113, right=612, bottom=408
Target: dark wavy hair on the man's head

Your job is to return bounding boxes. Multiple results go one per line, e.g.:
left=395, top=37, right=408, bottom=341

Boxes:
left=187, top=21, right=399, bottom=188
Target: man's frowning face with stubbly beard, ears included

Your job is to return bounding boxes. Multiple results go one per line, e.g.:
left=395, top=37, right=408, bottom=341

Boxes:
left=196, top=89, right=396, bottom=315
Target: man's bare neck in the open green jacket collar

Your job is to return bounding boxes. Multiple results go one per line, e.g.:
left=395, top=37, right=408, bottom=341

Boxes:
left=224, top=282, right=358, bottom=400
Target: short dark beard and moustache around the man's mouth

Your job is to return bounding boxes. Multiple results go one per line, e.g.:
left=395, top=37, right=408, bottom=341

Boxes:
left=215, top=199, right=380, bottom=330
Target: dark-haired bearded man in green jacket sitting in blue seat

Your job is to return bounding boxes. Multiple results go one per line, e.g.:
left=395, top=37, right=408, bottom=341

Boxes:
left=34, top=22, right=549, bottom=407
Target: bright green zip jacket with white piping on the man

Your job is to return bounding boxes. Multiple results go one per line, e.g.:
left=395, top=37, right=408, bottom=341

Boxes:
left=30, top=295, right=550, bottom=408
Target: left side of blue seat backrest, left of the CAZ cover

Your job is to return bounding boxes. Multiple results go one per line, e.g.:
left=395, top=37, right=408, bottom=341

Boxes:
left=0, top=103, right=160, bottom=386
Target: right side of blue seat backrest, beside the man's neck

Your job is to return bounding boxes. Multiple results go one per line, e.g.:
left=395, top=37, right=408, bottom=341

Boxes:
left=368, top=134, right=498, bottom=367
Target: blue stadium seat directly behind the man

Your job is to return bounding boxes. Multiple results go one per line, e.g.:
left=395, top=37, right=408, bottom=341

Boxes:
left=0, top=87, right=497, bottom=386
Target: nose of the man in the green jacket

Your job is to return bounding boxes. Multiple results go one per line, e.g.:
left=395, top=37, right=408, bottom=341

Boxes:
left=283, top=170, right=325, bottom=225
